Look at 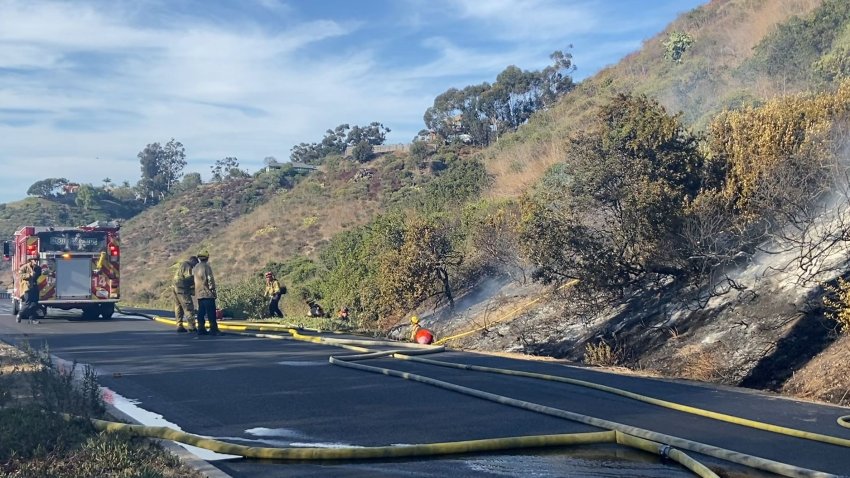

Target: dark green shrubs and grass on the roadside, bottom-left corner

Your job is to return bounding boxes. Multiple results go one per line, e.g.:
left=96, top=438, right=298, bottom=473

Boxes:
left=0, top=345, right=201, bottom=478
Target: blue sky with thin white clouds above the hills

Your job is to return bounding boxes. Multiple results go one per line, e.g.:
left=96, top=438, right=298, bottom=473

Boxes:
left=0, top=0, right=705, bottom=203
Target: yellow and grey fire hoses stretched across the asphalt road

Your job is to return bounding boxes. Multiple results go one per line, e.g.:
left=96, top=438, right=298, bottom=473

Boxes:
left=89, top=317, right=850, bottom=477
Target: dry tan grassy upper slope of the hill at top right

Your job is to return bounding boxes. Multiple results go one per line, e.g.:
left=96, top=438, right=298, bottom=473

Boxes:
left=484, top=0, right=822, bottom=197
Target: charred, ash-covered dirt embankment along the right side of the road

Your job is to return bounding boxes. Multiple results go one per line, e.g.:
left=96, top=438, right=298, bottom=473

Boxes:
left=428, top=257, right=850, bottom=405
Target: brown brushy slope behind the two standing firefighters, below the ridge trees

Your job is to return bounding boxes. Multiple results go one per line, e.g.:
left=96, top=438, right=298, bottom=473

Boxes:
left=122, top=154, right=432, bottom=307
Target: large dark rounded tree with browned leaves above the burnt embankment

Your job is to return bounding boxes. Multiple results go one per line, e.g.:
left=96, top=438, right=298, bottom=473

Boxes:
left=522, top=95, right=704, bottom=292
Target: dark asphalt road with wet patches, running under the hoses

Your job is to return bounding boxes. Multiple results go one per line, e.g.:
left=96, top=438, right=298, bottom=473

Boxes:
left=0, top=304, right=850, bottom=477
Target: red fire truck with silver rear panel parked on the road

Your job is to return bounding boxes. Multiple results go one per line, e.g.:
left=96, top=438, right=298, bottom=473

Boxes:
left=3, top=221, right=121, bottom=320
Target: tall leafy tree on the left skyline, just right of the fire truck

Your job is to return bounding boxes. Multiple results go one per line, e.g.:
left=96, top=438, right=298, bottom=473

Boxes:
left=138, top=138, right=186, bottom=204
